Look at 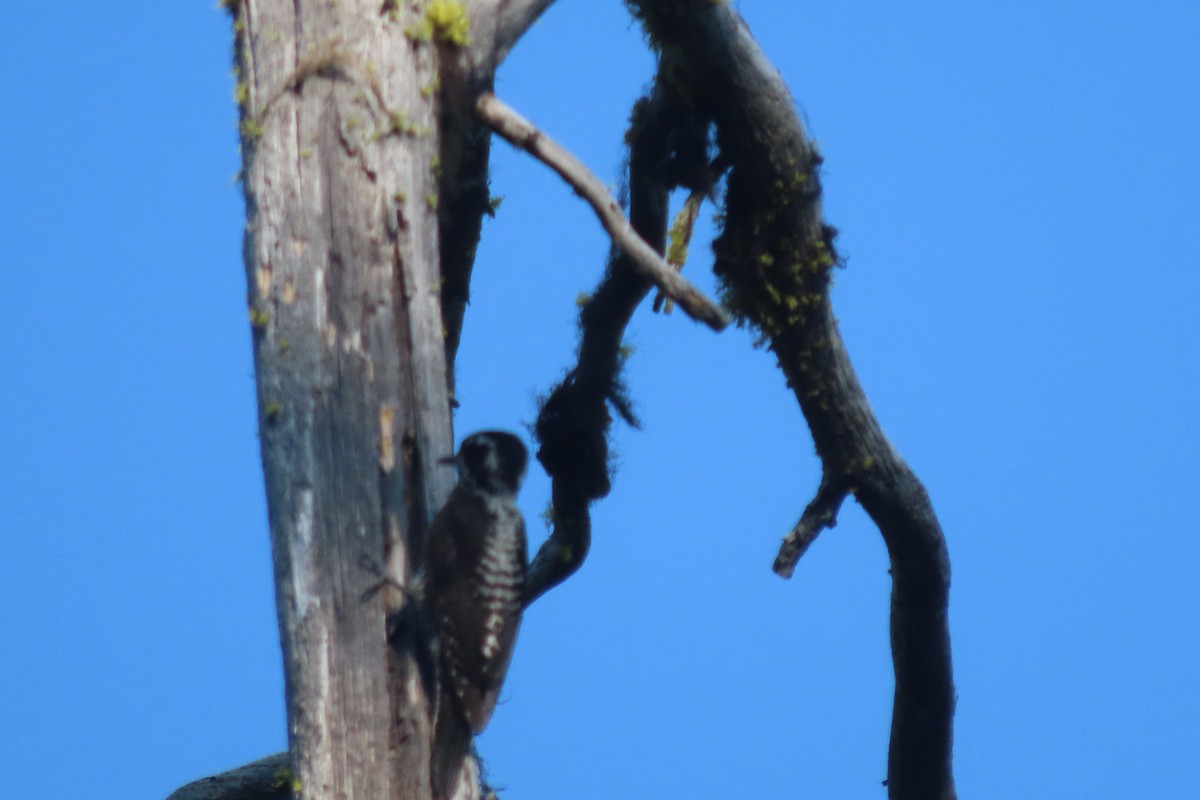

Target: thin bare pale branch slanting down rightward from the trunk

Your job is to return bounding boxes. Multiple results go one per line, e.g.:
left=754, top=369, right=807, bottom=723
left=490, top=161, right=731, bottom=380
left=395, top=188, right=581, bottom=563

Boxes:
left=475, top=92, right=730, bottom=331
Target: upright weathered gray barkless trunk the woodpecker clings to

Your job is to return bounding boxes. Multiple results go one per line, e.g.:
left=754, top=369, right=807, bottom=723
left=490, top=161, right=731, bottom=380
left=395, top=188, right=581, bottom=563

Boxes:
left=235, top=0, right=452, bottom=799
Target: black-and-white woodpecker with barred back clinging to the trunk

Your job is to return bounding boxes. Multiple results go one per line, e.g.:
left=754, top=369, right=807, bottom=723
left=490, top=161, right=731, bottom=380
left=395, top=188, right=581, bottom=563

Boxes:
left=426, top=431, right=529, bottom=796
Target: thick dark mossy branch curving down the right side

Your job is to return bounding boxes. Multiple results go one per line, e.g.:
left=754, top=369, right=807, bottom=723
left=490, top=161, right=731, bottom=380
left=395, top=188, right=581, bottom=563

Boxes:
left=629, top=0, right=955, bottom=800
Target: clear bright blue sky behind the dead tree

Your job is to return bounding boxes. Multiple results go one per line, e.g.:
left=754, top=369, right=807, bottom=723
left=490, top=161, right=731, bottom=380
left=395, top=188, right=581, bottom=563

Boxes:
left=0, top=0, right=1200, bottom=800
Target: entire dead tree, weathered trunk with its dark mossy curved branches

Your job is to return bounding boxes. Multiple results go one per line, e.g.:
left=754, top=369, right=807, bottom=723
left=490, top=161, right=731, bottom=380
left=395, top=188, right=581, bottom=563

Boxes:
left=173, top=0, right=955, bottom=800
